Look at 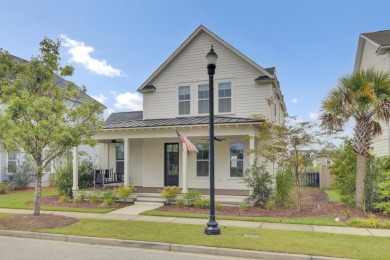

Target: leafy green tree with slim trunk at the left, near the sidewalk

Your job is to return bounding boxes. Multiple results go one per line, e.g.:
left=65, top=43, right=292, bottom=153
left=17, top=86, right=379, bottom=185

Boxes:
left=0, top=38, right=103, bottom=215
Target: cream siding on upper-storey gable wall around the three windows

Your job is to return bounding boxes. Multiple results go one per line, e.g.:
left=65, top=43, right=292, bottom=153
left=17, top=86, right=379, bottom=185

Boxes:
left=144, top=33, right=272, bottom=119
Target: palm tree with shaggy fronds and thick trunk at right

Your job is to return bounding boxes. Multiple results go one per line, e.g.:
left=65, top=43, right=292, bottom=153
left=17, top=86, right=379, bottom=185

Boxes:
left=320, top=69, right=390, bottom=210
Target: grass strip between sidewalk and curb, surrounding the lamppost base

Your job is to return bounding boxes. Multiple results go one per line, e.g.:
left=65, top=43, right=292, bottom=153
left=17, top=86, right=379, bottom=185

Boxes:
left=39, top=219, right=390, bottom=260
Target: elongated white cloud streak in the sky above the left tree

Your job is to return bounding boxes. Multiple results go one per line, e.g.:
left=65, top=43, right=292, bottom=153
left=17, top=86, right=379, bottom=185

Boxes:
left=60, top=34, right=123, bottom=77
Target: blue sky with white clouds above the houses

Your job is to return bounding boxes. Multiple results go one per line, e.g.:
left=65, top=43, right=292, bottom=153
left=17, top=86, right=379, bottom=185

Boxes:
left=0, top=0, right=390, bottom=120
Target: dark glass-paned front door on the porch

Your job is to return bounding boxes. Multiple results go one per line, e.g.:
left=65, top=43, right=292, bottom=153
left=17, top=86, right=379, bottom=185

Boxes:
left=164, top=143, right=179, bottom=186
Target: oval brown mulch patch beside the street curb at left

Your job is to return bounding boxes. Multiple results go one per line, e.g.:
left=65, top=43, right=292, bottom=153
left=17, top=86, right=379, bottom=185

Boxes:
left=0, top=214, right=79, bottom=231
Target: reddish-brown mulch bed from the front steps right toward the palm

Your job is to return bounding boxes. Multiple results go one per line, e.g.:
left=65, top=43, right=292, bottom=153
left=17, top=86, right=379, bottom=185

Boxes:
left=157, top=188, right=390, bottom=220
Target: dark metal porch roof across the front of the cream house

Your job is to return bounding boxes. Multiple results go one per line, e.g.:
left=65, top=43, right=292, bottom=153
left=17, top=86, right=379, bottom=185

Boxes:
left=103, top=111, right=262, bottom=129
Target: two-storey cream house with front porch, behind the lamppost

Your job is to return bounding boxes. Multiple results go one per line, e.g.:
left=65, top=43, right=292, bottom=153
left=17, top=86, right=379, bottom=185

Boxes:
left=91, top=26, right=287, bottom=195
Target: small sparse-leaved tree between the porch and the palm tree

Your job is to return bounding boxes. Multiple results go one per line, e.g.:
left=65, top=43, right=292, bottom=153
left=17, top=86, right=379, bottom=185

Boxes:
left=256, top=118, right=330, bottom=210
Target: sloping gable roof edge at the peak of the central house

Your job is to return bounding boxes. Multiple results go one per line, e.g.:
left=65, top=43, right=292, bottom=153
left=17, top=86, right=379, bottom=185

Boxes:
left=137, top=25, right=275, bottom=93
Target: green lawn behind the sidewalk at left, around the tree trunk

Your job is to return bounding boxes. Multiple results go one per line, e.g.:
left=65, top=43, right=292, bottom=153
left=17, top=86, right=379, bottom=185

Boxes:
left=0, top=189, right=115, bottom=213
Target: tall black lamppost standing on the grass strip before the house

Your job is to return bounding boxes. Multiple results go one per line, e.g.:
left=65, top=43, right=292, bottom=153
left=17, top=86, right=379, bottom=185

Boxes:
left=204, top=45, right=221, bottom=235
